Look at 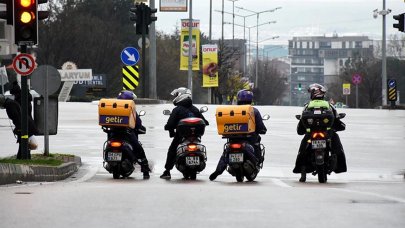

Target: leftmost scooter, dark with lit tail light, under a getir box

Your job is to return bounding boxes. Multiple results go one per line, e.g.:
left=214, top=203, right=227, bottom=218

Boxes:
left=102, top=110, right=146, bottom=179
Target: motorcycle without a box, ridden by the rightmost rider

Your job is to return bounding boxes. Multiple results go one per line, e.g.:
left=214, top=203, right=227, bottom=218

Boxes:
left=295, top=107, right=346, bottom=183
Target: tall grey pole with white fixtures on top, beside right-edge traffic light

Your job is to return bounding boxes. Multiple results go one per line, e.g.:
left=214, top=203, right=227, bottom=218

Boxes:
left=373, top=0, right=391, bottom=106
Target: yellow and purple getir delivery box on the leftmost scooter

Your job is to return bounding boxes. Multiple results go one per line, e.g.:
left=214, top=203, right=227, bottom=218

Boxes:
left=98, top=98, right=136, bottom=128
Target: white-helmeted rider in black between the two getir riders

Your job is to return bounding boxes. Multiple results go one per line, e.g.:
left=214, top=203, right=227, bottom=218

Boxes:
left=160, top=87, right=208, bottom=180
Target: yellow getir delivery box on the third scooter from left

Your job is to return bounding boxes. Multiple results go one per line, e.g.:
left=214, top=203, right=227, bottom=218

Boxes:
left=215, top=105, right=256, bottom=135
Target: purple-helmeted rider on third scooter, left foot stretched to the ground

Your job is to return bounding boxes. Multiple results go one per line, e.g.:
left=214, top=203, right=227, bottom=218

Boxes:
left=210, top=89, right=267, bottom=181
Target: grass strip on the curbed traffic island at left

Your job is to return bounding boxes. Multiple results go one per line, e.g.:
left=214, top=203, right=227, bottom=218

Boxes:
left=0, top=154, right=74, bottom=166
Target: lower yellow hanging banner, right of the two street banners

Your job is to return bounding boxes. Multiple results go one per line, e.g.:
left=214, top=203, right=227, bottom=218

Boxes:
left=202, top=44, right=218, bottom=87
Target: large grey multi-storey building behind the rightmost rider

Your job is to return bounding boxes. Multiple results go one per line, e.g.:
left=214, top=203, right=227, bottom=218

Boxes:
left=288, top=34, right=373, bottom=106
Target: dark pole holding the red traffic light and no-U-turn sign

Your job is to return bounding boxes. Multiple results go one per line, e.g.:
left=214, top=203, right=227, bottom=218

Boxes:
left=19, top=44, right=31, bottom=159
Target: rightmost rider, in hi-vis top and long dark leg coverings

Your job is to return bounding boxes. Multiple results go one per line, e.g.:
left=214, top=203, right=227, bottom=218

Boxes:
left=293, top=83, right=347, bottom=182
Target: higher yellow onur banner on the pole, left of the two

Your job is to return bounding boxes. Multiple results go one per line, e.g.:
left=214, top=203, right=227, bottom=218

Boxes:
left=180, top=19, right=200, bottom=70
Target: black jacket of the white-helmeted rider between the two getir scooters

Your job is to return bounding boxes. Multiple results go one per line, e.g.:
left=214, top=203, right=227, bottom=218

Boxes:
left=165, top=99, right=209, bottom=132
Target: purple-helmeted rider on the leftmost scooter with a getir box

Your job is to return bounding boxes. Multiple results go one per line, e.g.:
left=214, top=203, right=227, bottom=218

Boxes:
left=117, top=90, right=150, bottom=179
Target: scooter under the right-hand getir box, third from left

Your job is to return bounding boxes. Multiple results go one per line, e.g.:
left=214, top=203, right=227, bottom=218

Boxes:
left=222, top=114, right=270, bottom=182
